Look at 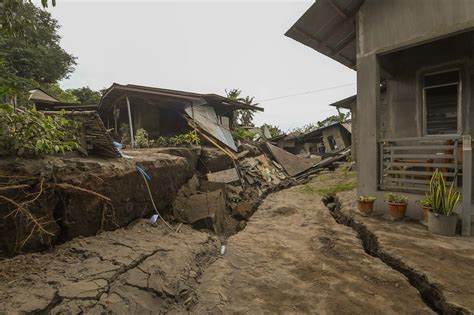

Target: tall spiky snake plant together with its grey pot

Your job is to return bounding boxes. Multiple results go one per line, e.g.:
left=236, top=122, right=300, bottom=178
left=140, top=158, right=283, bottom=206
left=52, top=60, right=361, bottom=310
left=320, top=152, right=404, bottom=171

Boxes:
left=428, top=169, right=461, bottom=236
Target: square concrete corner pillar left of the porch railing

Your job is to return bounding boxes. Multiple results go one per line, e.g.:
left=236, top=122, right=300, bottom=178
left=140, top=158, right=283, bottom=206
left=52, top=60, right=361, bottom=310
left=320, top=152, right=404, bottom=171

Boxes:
left=356, top=55, right=380, bottom=195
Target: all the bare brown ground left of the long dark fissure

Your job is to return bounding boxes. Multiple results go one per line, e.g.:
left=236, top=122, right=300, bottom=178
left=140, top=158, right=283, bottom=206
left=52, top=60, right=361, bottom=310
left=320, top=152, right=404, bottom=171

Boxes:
left=0, top=172, right=433, bottom=314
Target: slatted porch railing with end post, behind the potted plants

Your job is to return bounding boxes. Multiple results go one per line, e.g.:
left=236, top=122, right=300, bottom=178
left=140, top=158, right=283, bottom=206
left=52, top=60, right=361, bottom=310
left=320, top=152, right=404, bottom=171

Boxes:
left=378, top=135, right=472, bottom=235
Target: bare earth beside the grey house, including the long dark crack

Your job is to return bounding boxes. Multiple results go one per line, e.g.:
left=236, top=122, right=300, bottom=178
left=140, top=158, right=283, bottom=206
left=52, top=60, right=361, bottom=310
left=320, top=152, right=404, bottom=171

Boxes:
left=327, top=191, right=474, bottom=314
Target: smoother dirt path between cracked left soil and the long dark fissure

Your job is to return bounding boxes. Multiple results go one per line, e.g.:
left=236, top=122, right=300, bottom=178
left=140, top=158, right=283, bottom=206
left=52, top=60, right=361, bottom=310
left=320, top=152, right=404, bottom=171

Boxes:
left=194, top=186, right=431, bottom=314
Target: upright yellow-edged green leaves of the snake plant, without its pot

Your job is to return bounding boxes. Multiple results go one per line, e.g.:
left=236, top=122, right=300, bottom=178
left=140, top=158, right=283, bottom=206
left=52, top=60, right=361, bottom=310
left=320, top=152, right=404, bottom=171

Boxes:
left=428, top=169, right=461, bottom=216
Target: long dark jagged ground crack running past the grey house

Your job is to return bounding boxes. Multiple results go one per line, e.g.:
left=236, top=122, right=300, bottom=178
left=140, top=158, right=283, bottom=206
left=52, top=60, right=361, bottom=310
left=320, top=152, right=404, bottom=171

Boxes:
left=323, top=197, right=471, bottom=314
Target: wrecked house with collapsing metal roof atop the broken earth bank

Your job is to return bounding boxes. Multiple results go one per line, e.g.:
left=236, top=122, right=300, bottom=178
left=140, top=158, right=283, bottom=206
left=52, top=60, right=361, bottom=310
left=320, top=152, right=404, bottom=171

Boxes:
left=98, top=83, right=263, bottom=152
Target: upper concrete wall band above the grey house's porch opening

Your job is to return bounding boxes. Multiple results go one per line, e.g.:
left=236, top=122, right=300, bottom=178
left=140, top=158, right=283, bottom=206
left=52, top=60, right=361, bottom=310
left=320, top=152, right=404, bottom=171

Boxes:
left=357, top=0, right=474, bottom=56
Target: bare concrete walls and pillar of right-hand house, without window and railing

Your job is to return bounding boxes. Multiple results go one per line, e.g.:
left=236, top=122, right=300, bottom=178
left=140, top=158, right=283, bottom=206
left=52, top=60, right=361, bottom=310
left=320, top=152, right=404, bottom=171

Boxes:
left=353, top=0, right=474, bottom=222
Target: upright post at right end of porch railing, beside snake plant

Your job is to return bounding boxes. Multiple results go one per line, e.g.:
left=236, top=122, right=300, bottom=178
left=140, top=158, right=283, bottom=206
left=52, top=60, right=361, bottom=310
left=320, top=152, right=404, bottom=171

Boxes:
left=462, top=135, right=472, bottom=236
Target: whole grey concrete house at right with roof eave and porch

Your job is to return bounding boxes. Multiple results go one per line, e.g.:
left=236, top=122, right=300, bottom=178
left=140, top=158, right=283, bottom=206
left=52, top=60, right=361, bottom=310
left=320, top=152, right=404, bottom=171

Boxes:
left=286, top=0, right=474, bottom=235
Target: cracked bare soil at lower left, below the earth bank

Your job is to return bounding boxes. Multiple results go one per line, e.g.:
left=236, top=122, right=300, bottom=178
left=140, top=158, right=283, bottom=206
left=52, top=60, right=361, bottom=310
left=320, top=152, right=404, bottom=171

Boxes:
left=0, top=220, right=219, bottom=314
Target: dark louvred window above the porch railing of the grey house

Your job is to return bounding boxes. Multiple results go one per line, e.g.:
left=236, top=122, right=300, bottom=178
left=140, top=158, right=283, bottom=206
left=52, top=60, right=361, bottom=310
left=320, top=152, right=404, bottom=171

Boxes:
left=423, top=70, right=461, bottom=135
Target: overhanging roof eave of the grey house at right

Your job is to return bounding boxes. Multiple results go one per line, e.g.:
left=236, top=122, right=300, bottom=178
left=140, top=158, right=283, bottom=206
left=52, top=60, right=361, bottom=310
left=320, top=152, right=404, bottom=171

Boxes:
left=285, top=0, right=364, bottom=69
